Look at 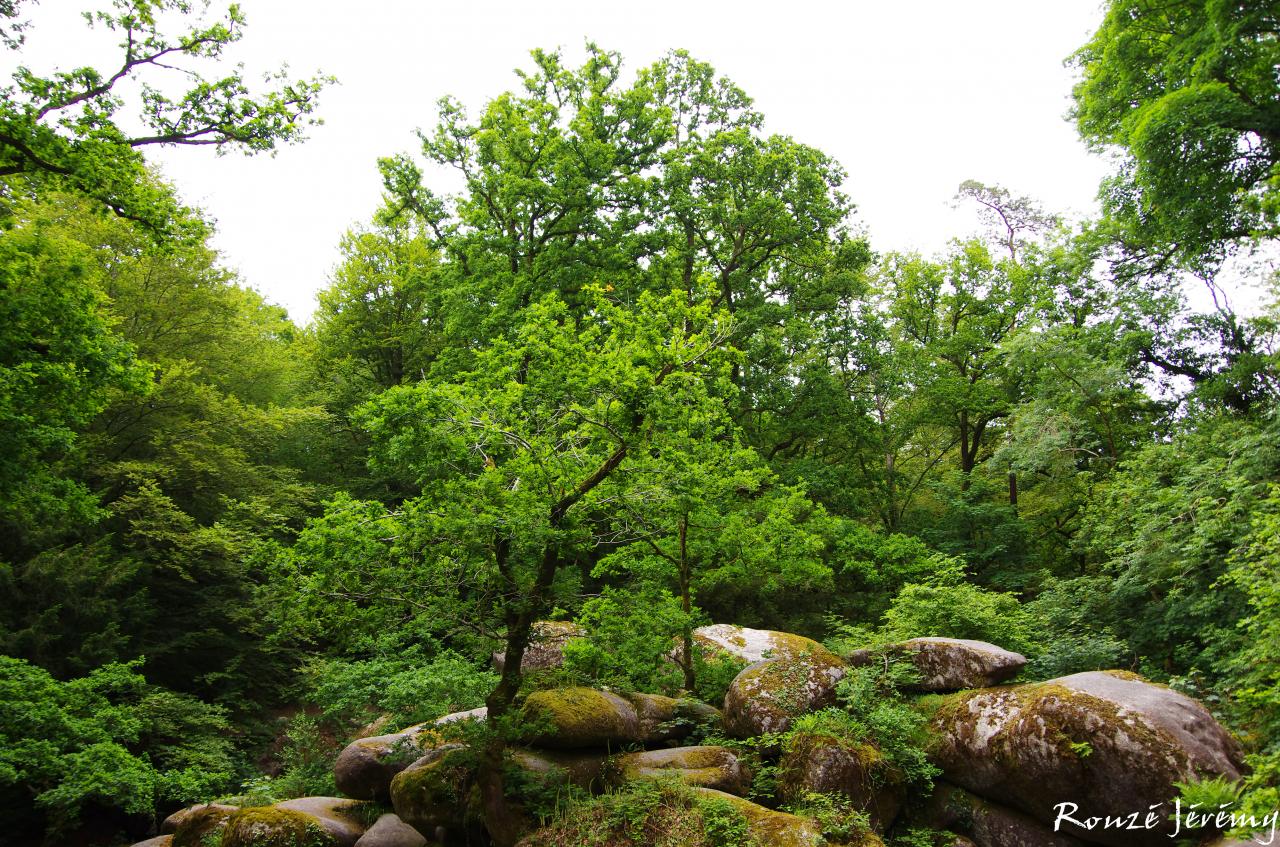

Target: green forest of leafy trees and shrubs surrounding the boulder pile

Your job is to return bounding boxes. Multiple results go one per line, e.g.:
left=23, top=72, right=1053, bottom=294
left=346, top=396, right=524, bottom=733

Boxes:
left=0, top=0, right=1280, bottom=847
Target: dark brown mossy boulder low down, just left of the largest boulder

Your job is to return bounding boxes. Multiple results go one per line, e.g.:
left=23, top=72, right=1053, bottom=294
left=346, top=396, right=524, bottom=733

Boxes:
left=778, top=731, right=906, bottom=832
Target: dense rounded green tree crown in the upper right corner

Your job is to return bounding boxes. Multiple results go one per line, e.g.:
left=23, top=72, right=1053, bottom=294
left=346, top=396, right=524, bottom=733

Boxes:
left=1071, top=0, right=1280, bottom=267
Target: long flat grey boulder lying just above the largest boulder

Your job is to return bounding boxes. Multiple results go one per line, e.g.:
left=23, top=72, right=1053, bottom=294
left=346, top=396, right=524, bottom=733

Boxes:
left=849, top=637, right=1027, bottom=692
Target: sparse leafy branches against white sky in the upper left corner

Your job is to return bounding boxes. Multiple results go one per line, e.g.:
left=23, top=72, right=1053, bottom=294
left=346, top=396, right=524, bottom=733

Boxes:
left=0, top=0, right=332, bottom=234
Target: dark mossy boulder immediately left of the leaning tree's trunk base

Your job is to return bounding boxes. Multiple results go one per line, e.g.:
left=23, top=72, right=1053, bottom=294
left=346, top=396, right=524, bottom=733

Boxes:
left=390, top=743, right=477, bottom=835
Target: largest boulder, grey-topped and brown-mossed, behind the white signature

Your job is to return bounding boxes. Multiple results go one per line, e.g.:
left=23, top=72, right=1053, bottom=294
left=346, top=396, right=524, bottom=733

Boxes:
left=929, top=670, right=1242, bottom=847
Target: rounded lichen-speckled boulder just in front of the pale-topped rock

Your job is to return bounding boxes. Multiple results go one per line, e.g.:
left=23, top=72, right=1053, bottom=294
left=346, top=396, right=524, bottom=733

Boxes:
left=724, top=645, right=845, bottom=738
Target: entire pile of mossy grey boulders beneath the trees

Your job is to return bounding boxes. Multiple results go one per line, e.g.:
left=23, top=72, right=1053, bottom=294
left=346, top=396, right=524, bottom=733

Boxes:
left=154, top=624, right=1249, bottom=847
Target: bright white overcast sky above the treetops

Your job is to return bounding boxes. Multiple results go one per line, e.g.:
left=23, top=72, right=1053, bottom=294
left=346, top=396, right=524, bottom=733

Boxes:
left=22, top=0, right=1106, bottom=321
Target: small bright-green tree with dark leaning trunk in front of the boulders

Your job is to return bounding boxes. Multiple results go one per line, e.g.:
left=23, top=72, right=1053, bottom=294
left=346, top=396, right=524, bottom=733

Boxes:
left=355, top=290, right=732, bottom=841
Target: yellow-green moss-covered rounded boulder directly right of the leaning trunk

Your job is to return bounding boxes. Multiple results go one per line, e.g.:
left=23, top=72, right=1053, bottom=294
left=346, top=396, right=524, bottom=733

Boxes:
left=524, top=688, right=644, bottom=750
